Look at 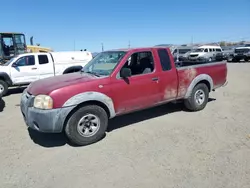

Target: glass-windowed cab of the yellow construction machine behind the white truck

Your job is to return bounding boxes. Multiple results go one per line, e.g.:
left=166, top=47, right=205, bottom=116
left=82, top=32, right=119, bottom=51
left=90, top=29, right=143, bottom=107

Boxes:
left=0, top=33, right=27, bottom=64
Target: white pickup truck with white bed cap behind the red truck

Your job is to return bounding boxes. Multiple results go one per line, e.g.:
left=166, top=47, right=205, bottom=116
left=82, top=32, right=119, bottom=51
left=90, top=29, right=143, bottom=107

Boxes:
left=0, top=51, right=93, bottom=96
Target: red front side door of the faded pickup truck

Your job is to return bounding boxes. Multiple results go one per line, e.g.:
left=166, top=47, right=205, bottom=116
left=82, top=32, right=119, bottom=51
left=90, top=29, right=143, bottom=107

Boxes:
left=111, top=50, right=160, bottom=114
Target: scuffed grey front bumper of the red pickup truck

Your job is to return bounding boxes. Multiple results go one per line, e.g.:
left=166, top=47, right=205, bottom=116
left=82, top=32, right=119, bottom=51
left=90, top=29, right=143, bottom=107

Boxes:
left=20, top=90, right=75, bottom=133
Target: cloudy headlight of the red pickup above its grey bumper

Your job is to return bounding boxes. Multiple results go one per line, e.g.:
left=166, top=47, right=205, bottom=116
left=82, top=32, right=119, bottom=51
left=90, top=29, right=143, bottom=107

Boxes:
left=34, top=95, right=53, bottom=110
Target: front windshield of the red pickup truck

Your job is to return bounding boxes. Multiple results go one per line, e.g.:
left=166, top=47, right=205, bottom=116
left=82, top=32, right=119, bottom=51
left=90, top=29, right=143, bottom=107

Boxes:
left=82, top=51, right=126, bottom=76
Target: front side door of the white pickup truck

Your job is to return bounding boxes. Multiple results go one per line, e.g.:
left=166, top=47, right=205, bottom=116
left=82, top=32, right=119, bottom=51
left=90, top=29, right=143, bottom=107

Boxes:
left=11, top=55, right=39, bottom=84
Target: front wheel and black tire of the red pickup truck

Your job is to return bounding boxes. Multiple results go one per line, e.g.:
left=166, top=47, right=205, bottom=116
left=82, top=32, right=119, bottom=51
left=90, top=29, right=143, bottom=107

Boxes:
left=65, top=105, right=108, bottom=146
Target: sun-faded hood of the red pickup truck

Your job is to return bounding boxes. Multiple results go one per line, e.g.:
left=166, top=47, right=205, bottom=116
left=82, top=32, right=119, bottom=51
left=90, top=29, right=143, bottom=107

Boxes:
left=27, top=72, right=98, bottom=95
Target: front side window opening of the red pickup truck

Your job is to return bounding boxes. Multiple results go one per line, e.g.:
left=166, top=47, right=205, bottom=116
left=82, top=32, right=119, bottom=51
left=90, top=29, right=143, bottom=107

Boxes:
left=123, top=51, right=155, bottom=76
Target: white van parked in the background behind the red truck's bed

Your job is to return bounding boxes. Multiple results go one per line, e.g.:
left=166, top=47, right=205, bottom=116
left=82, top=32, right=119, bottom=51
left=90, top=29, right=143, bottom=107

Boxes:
left=188, top=45, right=222, bottom=62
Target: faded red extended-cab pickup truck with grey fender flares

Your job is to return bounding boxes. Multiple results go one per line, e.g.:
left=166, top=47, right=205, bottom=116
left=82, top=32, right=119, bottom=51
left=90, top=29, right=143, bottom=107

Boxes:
left=20, top=47, right=227, bottom=145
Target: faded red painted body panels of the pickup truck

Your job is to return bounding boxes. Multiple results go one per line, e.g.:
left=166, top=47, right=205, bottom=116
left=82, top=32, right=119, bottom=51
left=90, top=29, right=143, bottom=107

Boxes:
left=28, top=47, right=227, bottom=114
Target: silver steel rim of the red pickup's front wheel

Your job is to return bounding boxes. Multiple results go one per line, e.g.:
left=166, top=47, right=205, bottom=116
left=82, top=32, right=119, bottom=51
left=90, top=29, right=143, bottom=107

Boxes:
left=77, top=114, right=100, bottom=137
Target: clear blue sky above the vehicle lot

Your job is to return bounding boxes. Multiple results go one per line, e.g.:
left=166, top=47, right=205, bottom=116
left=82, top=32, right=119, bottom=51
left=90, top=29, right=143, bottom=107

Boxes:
left=0, top=0, right=250, bottom=52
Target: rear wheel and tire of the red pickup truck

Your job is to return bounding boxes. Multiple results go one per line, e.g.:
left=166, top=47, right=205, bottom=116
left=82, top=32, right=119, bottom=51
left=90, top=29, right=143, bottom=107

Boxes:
left=184, top=83, right=209, bottom=111
